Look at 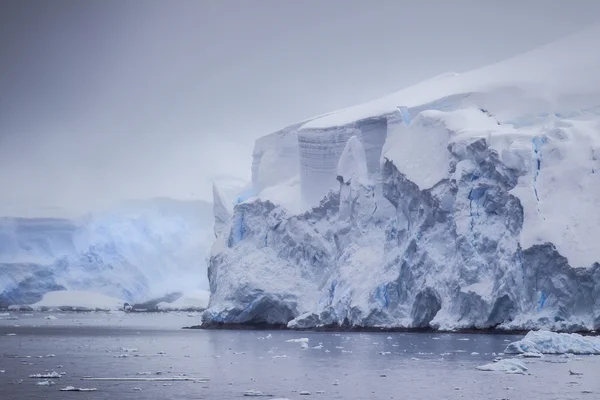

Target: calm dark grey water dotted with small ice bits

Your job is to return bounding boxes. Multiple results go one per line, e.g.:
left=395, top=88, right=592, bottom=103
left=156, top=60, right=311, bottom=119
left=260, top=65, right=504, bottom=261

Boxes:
left=0, top=314, right=600, bottom=400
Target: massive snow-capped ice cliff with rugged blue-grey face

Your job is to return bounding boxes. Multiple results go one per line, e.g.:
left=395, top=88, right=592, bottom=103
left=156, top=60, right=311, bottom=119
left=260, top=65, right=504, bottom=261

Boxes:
left=204, top=27, right=600, bottom=331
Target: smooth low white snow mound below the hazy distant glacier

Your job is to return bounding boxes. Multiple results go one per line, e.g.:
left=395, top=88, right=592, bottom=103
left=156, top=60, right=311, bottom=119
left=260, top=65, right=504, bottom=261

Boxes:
left=31, top=290, right=125, bottom=311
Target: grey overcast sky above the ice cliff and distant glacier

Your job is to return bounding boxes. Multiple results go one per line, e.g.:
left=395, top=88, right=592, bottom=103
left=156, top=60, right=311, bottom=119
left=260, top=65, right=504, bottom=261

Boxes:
left=0, top=0, right=600, bottom=216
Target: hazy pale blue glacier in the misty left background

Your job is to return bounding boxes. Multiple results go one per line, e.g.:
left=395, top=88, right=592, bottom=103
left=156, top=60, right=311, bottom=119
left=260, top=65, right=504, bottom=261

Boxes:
left=0, top=198, right=214, bottom=307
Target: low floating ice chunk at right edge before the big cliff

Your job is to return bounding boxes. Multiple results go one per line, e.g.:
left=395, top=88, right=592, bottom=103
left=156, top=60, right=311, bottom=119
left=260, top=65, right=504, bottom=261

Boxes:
left=504, top=331, right=600, bottom=355
